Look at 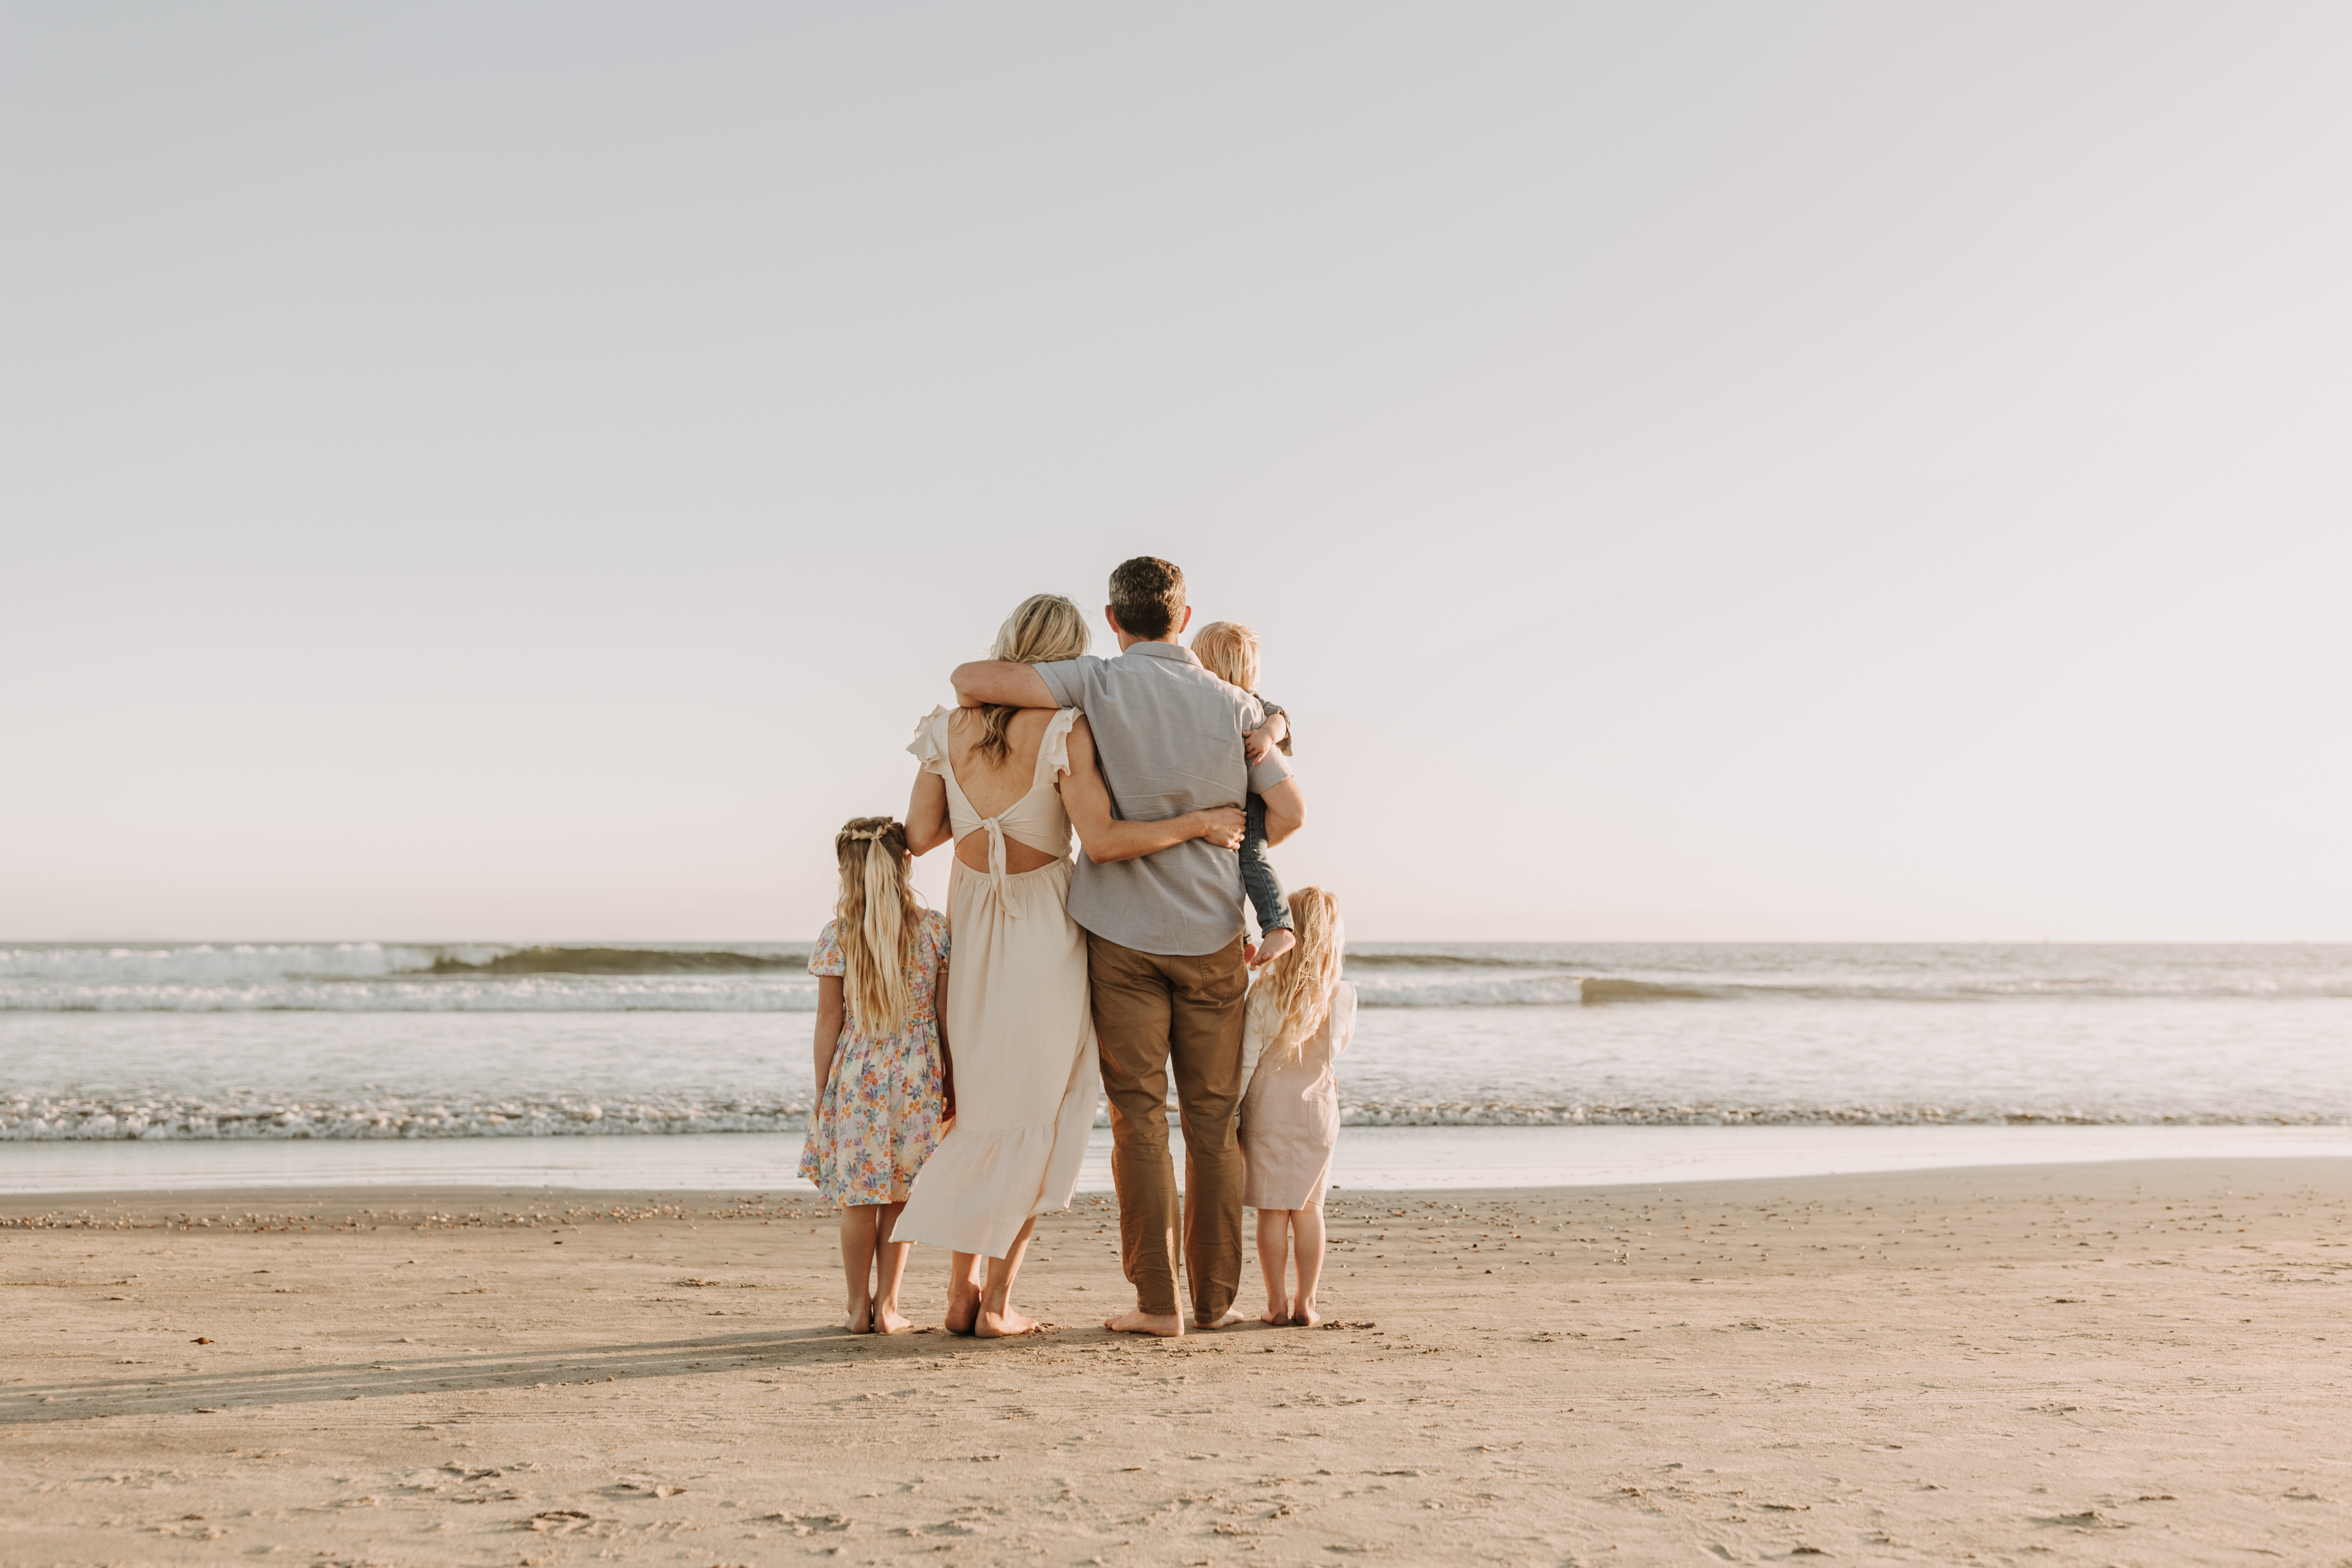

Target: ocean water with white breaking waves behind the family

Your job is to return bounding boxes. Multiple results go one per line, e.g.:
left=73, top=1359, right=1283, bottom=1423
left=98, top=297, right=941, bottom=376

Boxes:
left=0, top=943, right=2352, bottom=1145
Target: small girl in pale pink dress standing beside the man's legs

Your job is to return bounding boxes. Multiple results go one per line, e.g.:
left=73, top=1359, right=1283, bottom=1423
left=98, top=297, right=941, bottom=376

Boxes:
left=1242, top=888, right=1355, bottom=1328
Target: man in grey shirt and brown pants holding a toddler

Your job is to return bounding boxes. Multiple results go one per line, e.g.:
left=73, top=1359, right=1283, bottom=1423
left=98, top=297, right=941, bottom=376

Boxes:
left=952, top=555, right=1305, bottom=1335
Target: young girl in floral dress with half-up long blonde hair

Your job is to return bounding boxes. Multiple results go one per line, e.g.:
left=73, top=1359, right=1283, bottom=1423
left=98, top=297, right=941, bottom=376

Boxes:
left=799, top=816, right=950, bottom=1333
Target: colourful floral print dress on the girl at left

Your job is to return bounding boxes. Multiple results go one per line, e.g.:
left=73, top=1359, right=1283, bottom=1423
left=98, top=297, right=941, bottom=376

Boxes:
left=799, top=910, right=948, bottom=1204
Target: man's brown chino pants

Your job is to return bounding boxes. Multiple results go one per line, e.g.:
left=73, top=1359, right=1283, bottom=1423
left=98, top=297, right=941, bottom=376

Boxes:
left=1087, top=931, right=1249, bottom=1323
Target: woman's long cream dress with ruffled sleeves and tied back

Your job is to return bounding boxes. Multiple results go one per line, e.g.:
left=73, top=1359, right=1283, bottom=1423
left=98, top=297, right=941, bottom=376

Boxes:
left=891, top=707, right=1101, bottom=1258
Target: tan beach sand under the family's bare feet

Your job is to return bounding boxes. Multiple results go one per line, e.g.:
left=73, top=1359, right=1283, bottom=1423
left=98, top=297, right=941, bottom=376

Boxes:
left=0, top=1159, right=2352, bottom=1568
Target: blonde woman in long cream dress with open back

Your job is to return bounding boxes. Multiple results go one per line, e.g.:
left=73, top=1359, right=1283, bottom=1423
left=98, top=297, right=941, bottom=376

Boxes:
left=891, top=592, right=1240, bottom=1338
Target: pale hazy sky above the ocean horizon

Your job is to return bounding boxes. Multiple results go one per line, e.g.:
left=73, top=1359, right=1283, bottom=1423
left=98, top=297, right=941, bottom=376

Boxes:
left=0, top=0, right=2352, bottom=940
